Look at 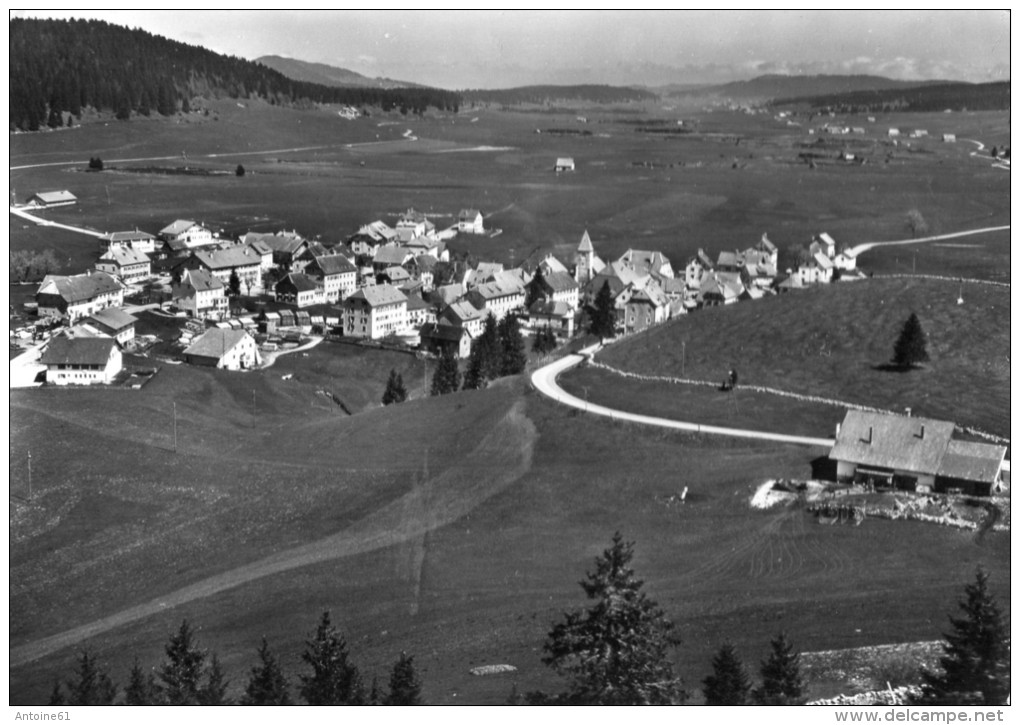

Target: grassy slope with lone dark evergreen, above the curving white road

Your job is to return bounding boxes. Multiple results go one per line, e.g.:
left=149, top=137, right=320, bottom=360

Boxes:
left=591, top=277, right=1010, bottom=436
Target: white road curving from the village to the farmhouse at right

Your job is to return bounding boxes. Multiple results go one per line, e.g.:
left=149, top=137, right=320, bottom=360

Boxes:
left=531, top=345, right=835, bottom=450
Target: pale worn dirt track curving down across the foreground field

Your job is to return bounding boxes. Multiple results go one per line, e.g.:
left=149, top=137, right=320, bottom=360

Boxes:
left=10, top=402, right=538, bottom=667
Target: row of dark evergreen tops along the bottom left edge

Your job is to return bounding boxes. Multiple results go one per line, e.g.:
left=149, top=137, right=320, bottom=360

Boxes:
left=49, top=612, right=424, bottom=706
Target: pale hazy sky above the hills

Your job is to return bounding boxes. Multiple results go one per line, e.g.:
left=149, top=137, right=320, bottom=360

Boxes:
left=11, top=9, right=1010, bottom=89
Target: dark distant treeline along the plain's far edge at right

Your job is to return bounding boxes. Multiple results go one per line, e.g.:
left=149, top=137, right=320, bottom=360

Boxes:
left=782, top=81, right=1010, bottom=113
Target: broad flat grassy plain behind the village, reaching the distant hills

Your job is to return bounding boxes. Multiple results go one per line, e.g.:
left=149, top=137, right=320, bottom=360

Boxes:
left=11, top=103, right=1010, bottom=276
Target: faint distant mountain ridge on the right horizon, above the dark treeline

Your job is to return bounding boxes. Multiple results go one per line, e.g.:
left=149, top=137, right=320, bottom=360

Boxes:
left=669, top=74, right=954, bottom=101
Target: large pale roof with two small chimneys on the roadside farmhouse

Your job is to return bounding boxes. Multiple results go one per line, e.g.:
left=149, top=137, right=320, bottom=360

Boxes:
left=829, top=410, right=956, bottom=474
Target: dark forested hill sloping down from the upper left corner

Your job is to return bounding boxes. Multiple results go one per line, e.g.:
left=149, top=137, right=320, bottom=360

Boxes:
left=9, top=18, right=460, bottom=131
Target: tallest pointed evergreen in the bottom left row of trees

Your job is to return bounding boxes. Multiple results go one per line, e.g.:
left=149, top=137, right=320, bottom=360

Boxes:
left=301, top=611, right=365, bottom=705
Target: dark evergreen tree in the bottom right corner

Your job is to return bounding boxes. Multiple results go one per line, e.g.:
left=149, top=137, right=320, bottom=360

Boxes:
left=917, top=571, right=1010, bottom=705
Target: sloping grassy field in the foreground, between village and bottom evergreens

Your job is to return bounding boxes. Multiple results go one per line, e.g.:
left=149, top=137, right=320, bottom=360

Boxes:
left=10, top=366, right=1009, bottom=704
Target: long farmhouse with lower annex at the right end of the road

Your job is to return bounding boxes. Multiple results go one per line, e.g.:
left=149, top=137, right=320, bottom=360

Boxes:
left=829, top=410, right=1006, bottom=496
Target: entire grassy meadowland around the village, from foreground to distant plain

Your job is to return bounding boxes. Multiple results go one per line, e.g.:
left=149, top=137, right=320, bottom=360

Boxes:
left=9, top=96, right=1010, bottom=704
